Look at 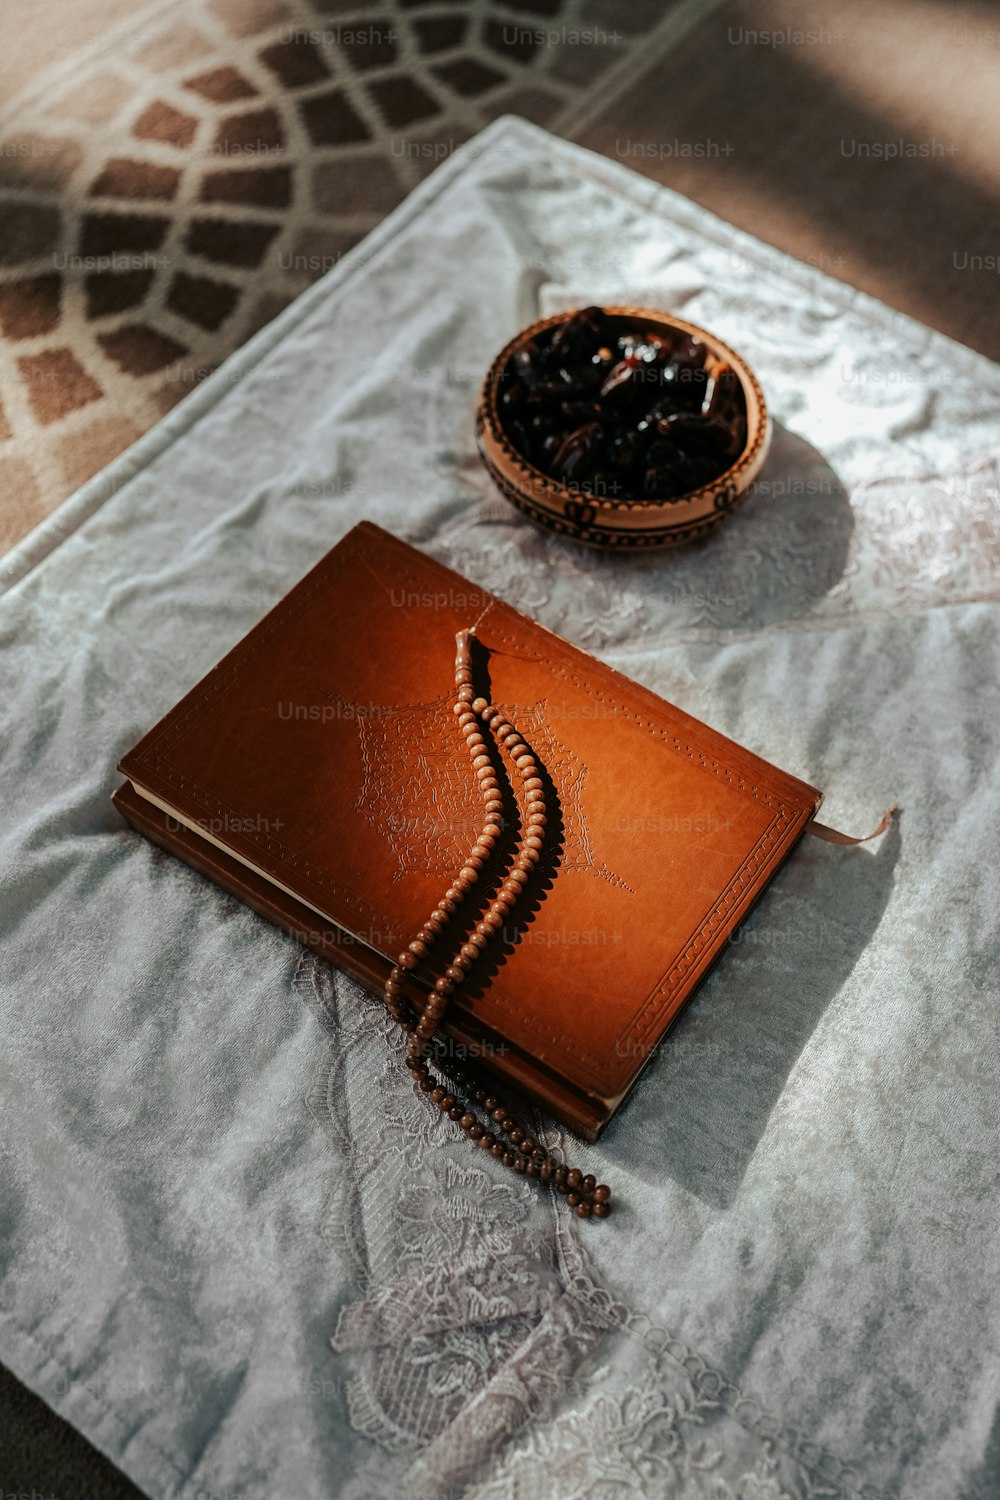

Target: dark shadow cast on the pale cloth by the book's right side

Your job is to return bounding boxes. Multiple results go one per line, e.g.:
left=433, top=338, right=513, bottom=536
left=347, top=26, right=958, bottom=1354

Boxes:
left=601, top=819, right=901, bottom=1208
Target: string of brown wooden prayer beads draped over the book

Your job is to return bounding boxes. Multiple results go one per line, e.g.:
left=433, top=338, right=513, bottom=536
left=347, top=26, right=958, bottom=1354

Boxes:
left=385, top=630, right=612, bottom=1218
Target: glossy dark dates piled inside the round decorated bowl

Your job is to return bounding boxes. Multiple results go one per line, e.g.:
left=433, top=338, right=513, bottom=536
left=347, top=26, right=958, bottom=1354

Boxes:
left=499, top=308, right=747, bottom=500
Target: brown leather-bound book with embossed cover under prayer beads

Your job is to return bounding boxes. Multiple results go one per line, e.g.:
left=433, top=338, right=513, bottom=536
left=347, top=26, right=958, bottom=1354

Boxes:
left=114, top=522, right=820, bottom=1140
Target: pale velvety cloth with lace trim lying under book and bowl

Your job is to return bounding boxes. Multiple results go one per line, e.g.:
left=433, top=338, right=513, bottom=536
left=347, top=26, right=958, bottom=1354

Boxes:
left=0, top=122, right=1000, bottom=1500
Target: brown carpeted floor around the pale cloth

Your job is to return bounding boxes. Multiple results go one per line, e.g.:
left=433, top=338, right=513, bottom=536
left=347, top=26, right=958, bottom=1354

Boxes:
left=0, top=0, right=1000, bottom=1500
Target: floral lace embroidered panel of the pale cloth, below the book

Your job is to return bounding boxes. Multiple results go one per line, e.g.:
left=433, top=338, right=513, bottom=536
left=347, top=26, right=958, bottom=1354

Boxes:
left=295, top=954, right=880, bottom=1500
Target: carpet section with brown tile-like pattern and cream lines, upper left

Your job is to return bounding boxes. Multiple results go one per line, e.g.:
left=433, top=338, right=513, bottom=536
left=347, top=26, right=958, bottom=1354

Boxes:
left=0, top=0, right=685, bottom=551
